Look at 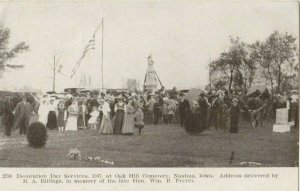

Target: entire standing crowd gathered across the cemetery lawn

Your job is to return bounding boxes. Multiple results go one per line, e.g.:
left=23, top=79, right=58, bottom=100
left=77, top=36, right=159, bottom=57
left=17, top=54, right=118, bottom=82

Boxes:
left=2, top=86, right=298, bottom=136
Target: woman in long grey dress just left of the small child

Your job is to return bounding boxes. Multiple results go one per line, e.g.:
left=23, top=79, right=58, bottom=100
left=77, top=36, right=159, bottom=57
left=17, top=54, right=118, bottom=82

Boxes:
left=122, top=97, right=135, bottom=135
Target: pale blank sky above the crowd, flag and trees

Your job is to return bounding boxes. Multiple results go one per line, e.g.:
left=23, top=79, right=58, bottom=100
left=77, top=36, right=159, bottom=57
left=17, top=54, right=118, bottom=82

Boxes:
left=0, top=1, right=299, bottom=91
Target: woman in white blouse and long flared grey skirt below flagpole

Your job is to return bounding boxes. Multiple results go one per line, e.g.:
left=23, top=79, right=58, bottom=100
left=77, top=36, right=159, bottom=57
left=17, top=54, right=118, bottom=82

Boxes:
left=99, top=100, right=113, bottom=134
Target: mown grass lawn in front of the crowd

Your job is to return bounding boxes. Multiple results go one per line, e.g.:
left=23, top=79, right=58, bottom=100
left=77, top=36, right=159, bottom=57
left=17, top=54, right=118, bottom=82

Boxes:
left=0, top=121, right=298, bottom=167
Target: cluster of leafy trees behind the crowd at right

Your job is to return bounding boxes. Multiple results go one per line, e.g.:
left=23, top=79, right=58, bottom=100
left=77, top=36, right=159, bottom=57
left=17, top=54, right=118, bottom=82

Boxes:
left=206, top=31, right=299, bottom=93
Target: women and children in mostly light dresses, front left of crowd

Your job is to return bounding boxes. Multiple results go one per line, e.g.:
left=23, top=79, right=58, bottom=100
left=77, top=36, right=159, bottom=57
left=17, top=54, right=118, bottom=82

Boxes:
left=38, top=93, right=144, bottom=135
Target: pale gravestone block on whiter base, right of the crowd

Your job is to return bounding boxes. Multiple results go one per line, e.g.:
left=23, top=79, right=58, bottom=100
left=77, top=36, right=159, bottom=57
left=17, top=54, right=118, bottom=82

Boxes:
left=273, top=108, right=291, bottom=133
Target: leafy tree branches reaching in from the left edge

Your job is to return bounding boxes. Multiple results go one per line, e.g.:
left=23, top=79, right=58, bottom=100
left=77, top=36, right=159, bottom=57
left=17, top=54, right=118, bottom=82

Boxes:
left=0, top=24, right=29, bottom=72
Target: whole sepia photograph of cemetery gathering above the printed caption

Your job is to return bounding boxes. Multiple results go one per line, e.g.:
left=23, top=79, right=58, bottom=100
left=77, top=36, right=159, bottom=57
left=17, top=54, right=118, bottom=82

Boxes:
left=0, top=1, right=299, bottom=168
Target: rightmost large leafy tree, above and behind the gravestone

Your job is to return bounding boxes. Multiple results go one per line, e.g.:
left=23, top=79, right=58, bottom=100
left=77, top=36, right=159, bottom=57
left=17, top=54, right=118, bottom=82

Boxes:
left=251, top=31, right=298, bottom=93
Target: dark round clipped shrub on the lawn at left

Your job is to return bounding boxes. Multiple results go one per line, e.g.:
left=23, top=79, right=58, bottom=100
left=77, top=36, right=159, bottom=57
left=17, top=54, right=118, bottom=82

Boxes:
left=27, top=122, right=48, bottom=148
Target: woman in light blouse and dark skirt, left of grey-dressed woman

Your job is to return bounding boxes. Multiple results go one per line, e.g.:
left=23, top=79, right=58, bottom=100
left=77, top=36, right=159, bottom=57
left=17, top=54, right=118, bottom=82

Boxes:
left=113, top=95, right=126, bottom=134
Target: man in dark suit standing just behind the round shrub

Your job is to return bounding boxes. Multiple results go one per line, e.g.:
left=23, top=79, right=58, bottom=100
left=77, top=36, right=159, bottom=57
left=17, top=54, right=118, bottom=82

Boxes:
left=15, top=96, right=32, bottom=135
